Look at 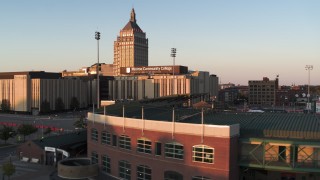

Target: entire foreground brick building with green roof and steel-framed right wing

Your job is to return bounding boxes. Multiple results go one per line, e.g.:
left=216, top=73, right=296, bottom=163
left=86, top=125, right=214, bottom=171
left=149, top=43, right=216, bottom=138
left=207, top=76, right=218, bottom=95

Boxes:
left=87, top=102, right=320, bottom=180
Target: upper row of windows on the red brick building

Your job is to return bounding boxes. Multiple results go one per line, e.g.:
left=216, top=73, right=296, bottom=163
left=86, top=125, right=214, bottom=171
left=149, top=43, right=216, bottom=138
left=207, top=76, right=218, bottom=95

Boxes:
left=91, top=128, right=214, bottom=164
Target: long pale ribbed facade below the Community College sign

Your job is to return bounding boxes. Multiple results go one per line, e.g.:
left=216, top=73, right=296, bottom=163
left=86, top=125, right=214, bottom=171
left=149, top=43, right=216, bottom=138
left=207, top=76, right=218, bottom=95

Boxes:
left=109, top=71, right=218, bottom=100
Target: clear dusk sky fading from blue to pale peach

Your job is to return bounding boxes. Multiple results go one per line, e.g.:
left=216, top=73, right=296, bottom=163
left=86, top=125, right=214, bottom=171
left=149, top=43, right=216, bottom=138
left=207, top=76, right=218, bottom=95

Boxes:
left=0, top=0, right=320, bottom=85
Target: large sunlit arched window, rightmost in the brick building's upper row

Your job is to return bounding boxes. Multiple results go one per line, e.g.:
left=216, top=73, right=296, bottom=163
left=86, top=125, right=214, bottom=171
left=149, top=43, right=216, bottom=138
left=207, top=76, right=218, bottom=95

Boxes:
left=192, top=145, right=214, bottom=163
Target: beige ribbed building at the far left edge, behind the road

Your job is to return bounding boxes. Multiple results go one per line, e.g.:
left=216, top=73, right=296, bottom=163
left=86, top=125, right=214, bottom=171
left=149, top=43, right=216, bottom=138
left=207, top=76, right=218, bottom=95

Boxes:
left=0, top=71, right=96, bottom=112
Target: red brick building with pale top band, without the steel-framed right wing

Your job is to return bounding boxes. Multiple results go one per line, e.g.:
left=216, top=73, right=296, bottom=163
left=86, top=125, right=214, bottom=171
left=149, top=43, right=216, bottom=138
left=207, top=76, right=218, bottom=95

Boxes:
left=88, top=102, right=239, bottom=180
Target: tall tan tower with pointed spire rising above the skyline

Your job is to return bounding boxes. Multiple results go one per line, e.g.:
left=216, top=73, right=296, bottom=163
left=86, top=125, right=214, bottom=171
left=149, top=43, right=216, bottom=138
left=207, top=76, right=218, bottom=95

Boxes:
left=113, top=9, right=148, bottom=76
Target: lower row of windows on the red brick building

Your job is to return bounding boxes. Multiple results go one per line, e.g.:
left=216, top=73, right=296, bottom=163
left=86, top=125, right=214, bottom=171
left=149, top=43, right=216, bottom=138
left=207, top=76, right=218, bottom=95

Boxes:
left=91, top=151, right=210, bottom=180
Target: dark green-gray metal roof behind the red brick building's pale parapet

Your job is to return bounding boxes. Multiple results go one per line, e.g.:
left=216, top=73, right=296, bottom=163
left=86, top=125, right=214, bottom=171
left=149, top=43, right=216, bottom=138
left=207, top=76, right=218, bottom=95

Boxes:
left=101, top=102, right=320, bottom=141
